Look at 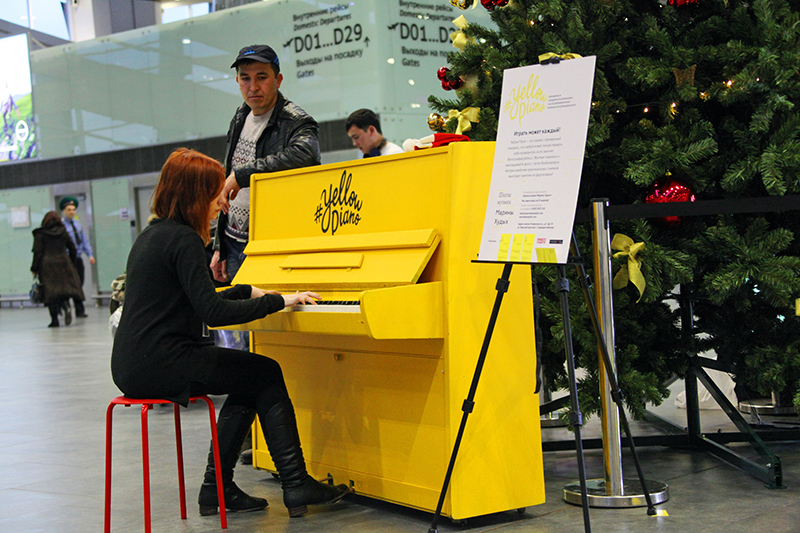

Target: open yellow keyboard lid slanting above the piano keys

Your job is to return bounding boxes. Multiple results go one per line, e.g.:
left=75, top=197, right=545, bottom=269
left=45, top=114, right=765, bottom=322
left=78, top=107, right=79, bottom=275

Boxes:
left=234, top=229, right=441, bottom=290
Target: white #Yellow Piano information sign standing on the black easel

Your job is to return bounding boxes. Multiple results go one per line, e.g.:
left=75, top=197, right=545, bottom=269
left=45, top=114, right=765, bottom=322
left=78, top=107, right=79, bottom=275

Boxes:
left=478, top=56, right=595, bottom=264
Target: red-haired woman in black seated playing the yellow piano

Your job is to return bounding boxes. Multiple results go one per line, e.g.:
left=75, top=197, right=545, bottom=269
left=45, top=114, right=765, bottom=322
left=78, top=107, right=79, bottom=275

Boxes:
left=111, top=148, right=349, bottom=517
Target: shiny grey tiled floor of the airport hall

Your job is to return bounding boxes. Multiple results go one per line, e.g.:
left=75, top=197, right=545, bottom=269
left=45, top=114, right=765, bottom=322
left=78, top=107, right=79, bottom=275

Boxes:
left=0, top=308, right=800, bottom=533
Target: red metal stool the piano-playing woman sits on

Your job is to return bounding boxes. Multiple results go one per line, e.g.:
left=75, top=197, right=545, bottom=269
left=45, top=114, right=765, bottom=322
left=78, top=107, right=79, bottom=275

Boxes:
left=103, top=396, right=228, bottom=533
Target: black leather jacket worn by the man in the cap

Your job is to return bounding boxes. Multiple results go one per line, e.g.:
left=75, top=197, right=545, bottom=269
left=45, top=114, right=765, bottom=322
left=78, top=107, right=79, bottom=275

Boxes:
left=213, top=92, right=320, bottom=260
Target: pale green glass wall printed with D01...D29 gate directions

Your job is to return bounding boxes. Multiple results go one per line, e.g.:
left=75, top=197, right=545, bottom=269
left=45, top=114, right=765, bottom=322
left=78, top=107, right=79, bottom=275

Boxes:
left=31, top=0, right=489, bottom=158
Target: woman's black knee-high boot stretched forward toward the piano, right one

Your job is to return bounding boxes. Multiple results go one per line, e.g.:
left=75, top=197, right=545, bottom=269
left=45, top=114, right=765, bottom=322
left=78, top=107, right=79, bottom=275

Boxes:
left=260, top=399, right=350, bottom=518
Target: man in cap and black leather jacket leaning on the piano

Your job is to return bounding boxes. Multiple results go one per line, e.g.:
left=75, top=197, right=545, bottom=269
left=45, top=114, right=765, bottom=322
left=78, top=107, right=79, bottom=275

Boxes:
left=211, top=44, right=320, bottom=281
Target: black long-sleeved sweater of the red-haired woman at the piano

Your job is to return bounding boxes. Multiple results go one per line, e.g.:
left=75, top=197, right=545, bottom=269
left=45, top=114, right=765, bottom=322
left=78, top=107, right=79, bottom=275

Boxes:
left=111, top=219, right=284, bottom=405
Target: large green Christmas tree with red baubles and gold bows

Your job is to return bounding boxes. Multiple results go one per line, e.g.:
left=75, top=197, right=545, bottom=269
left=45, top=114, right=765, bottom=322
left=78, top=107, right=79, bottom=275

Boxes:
left=430, top=0, right=800, bottom=415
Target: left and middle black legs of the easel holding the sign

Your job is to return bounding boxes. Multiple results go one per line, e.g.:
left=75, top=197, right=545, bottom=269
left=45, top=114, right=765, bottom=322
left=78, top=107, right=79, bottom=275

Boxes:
left=428, top=263, right=592, bottom=533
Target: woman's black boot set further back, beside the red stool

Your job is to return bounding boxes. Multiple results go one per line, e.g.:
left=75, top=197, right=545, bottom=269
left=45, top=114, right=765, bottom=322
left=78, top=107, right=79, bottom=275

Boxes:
left=197, top=402, right=269, bottom=516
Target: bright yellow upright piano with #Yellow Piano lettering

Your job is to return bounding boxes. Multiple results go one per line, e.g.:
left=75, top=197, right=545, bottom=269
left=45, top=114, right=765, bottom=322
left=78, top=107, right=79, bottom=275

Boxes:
left=228, top=143, right=544, bottom=519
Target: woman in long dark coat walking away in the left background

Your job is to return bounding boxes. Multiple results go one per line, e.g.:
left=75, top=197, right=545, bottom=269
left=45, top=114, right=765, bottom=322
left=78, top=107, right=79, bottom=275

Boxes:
left=31, top=211, right=83, bottom=328
